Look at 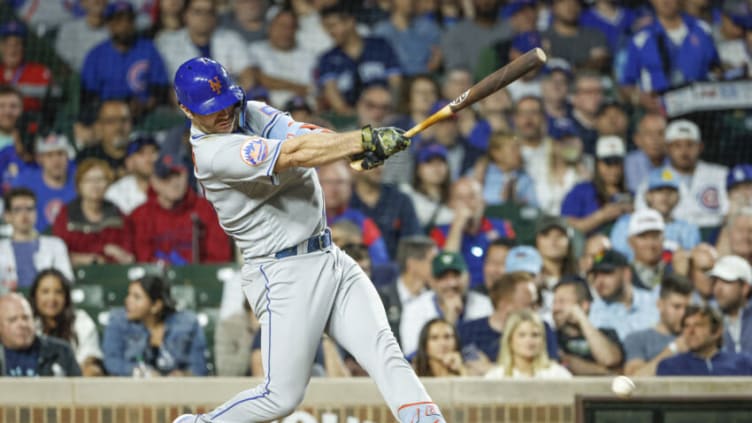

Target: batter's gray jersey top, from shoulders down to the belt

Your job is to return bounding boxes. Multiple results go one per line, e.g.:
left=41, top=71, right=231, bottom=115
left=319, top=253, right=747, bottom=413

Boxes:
left=191, top=101, right=326, bottom=259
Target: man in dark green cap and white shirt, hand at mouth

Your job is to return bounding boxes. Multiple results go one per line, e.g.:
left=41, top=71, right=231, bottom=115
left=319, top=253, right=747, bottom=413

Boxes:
left=400, top=251, right=493, bottom=356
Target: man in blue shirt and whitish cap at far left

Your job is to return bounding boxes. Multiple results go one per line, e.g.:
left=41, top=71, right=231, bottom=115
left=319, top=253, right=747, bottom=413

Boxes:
left=12, top=133, right=76, bottom=232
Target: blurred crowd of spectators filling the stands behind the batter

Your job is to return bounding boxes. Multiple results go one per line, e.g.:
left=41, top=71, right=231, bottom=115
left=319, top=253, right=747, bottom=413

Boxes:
left=0, top=0, right=752, bottom=379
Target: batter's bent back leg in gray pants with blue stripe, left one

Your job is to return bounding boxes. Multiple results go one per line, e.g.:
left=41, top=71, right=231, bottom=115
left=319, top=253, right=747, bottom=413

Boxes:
left=202, top=252, right=335, bottom=423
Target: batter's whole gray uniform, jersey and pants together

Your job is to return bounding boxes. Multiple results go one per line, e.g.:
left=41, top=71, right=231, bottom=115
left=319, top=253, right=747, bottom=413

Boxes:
left=185, top=102, right=444, bottom=423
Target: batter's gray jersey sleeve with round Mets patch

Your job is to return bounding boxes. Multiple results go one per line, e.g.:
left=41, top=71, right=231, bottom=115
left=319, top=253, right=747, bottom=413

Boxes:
left=203, top=134, right=283, bottom=183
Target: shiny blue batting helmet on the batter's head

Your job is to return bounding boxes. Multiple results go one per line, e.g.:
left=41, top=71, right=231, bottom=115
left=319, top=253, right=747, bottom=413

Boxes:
left=175, top=57, right=245, bottom=115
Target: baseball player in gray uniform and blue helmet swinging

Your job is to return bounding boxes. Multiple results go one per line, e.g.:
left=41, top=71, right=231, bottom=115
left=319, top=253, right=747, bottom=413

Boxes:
left=174, top=58, right=445, bottom=423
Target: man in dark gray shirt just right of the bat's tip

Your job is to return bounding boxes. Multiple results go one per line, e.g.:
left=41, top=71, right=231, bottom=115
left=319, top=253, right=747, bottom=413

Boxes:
left=542, top=0, right=609, bottom=70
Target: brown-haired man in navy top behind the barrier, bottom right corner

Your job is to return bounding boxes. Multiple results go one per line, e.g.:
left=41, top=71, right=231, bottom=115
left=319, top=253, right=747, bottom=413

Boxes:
left=656, top=305, right=752, bottom=376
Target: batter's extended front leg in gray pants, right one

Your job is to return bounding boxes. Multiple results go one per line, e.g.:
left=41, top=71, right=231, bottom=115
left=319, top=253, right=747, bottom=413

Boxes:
left=328, top=248, right=431, bottom=416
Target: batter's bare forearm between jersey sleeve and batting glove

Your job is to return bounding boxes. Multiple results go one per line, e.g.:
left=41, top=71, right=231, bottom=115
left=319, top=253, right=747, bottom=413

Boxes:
left=274, top=131, right=363, bottom=173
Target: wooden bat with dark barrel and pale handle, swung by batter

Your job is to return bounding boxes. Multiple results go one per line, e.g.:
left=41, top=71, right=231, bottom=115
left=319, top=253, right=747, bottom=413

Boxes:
left=350, top=47, right=547, bottom=171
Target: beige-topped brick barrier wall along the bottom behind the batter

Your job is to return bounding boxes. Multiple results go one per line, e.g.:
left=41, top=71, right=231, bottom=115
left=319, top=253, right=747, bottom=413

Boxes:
left=0, top=378, right=752, bottom=423
